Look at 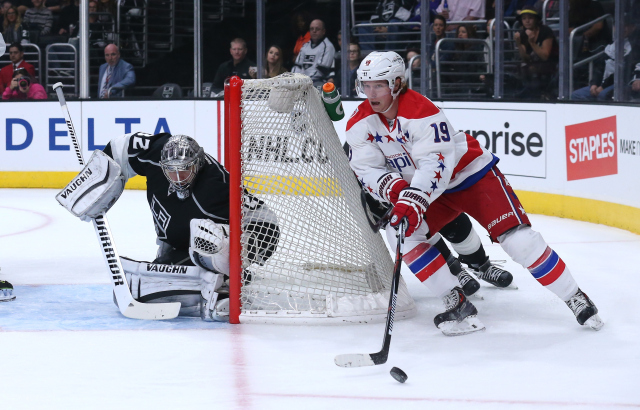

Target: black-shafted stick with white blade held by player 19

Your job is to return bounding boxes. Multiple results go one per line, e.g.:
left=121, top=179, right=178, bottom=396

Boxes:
left=333, top=219, right=407, bottom=367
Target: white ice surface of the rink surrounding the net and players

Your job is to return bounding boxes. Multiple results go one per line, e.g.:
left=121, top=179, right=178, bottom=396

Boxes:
left=0, top=189, right=640, bottom=410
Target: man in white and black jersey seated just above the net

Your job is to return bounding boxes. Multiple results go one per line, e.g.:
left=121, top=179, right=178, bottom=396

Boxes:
left=291, top=19, right=335, bottom=87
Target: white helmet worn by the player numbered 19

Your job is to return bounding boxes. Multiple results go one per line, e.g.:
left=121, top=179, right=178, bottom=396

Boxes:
left=356, top=51, right=405, bottom=99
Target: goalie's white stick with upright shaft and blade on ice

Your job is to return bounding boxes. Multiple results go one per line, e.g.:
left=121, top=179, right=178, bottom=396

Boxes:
left=53, top=83, right=180, bottom=320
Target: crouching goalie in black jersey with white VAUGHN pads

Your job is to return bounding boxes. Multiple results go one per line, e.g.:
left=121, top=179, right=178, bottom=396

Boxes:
left=60, top=132, right=280, bottom=320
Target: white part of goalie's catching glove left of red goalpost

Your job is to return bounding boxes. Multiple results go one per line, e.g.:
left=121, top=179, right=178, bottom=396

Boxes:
left=189, top=219, right=229, bottom=275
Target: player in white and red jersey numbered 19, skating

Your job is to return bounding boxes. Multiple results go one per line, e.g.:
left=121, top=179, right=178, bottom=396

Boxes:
left=347, top=52, right=604, bottom=334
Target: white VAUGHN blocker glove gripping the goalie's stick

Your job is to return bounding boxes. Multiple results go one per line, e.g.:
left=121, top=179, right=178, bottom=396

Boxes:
left=56, top=150, right=126, bottom=221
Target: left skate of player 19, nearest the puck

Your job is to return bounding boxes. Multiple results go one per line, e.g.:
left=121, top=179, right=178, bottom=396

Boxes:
left=433, top=286, right=485, bottom=336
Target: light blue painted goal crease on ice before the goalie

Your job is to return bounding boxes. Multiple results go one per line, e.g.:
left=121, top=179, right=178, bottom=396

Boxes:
left=0, top=285, right=230, bottom=331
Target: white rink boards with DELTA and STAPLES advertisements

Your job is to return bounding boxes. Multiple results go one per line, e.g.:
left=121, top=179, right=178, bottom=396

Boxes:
left=0, top=100, right=640, bottom=208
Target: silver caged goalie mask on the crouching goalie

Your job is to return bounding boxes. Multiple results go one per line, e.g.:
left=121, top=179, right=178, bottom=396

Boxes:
left=160, top=135, right=204, bottom=200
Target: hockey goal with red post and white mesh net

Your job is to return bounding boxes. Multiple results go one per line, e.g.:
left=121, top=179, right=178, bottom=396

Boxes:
left=224, top=74, right=416, bottom=324
